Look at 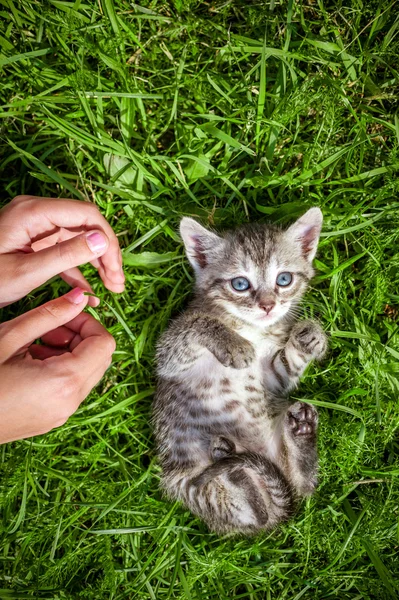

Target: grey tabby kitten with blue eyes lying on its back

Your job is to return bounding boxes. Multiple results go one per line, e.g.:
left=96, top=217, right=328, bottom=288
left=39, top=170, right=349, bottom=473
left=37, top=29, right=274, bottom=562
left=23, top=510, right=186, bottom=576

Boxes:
left=154, top=208, right=327, bottom=534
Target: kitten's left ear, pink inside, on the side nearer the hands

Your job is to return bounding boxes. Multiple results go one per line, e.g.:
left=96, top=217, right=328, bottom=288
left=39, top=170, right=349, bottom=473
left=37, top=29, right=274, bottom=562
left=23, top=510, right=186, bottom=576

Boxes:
left=180, top=217, right=222, bottom=272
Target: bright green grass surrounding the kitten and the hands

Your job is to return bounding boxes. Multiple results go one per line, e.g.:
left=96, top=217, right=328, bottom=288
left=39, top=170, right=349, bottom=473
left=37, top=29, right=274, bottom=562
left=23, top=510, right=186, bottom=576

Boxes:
left=0, top=0, right=399, bottom=600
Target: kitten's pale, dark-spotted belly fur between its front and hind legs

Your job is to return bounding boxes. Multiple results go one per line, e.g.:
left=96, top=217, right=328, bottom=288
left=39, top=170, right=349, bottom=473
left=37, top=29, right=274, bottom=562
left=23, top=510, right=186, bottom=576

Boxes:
left=185, top=351, right=282, bottom=462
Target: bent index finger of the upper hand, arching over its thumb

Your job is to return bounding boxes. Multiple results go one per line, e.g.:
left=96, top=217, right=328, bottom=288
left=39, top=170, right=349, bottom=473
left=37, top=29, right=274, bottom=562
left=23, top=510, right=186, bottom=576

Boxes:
left=6, top=196, right=124, bottom=289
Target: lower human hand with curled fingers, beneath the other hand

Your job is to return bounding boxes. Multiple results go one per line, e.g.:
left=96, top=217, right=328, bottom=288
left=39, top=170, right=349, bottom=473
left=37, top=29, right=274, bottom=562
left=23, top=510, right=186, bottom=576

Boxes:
left=0, top=288, right=115, bottom=444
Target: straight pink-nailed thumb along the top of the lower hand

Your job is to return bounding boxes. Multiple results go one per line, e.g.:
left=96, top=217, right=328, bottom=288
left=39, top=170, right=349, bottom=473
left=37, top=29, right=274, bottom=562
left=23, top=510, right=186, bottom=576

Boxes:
left=0, top=288, right=88, bottom=360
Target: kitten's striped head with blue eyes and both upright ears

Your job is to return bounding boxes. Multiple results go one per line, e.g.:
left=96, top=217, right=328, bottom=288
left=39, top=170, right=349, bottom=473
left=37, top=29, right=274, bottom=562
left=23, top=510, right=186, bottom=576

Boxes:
left=180, top=207, right=323, bottom=327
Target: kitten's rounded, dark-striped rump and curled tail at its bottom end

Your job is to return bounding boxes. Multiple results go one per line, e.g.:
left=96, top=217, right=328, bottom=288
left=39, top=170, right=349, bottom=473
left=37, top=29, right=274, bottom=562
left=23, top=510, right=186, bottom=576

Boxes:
left=180, top=453, right=294, bottom=534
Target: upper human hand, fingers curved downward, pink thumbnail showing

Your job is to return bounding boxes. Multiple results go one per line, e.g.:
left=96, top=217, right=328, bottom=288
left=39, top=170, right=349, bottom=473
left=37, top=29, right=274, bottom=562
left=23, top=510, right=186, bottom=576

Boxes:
left=0, top=196, right=125, bottom=307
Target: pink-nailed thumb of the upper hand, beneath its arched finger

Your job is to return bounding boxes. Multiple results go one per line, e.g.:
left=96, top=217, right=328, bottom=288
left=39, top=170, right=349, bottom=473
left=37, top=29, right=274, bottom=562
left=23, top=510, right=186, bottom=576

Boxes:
left=23, top=230, right=109, bottom=289
